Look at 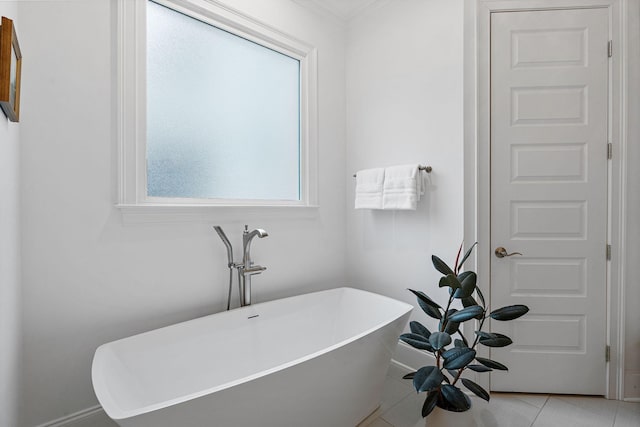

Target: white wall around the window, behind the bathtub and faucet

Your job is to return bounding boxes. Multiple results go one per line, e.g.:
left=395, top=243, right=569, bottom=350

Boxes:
left=20, top=0, right=345, bottom=427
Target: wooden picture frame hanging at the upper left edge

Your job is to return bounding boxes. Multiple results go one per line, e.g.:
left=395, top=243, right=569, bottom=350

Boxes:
left=0, top=16, right=22, bottom=122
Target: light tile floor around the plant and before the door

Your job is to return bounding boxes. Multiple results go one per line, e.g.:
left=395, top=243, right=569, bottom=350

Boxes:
left=358, top=364, right=640, bottom=427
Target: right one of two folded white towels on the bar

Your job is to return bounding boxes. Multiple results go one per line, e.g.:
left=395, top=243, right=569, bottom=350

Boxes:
left=382, top=164, right=426, bottom=210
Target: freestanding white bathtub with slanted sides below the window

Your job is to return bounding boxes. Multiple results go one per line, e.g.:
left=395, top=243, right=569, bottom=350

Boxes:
left=92, top=288, right=412, bottom=427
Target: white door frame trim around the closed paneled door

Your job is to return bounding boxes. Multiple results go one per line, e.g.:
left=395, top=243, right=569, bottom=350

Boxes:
left=464, top=0, right=628, bottom=400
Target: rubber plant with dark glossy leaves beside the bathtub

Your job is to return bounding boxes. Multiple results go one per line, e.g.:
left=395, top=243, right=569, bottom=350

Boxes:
left=400, top=243, right=529, bottom=417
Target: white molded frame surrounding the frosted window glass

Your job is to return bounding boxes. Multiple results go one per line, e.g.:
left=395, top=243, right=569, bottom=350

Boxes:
left=116, top=0, right=318, bottom=216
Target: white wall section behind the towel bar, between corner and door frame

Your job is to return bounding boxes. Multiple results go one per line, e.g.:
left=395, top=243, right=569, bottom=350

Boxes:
left=345, top=0, right=463, bottom=338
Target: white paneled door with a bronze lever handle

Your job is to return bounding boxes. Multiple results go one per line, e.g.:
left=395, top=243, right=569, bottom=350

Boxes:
left=491, top=9, right=609, bottom=395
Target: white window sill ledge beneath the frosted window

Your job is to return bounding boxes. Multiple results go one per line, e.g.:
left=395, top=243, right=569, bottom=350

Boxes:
left=115, top=204, right=319, bottom=224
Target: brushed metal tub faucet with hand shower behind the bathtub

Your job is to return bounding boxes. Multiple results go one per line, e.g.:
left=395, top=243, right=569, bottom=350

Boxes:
left=213, top=225, right=269, bottom=310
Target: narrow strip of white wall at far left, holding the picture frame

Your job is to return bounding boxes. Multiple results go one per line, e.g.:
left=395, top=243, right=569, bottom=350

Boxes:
left=0, top=1, right=21, bottom=426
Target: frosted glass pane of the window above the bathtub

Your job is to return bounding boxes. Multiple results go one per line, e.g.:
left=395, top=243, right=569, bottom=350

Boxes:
left=146, top=2, right=300, bottom=201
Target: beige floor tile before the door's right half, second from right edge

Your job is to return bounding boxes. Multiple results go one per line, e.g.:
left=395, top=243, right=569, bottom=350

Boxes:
left=533, top=396, right=618, bottom=427
